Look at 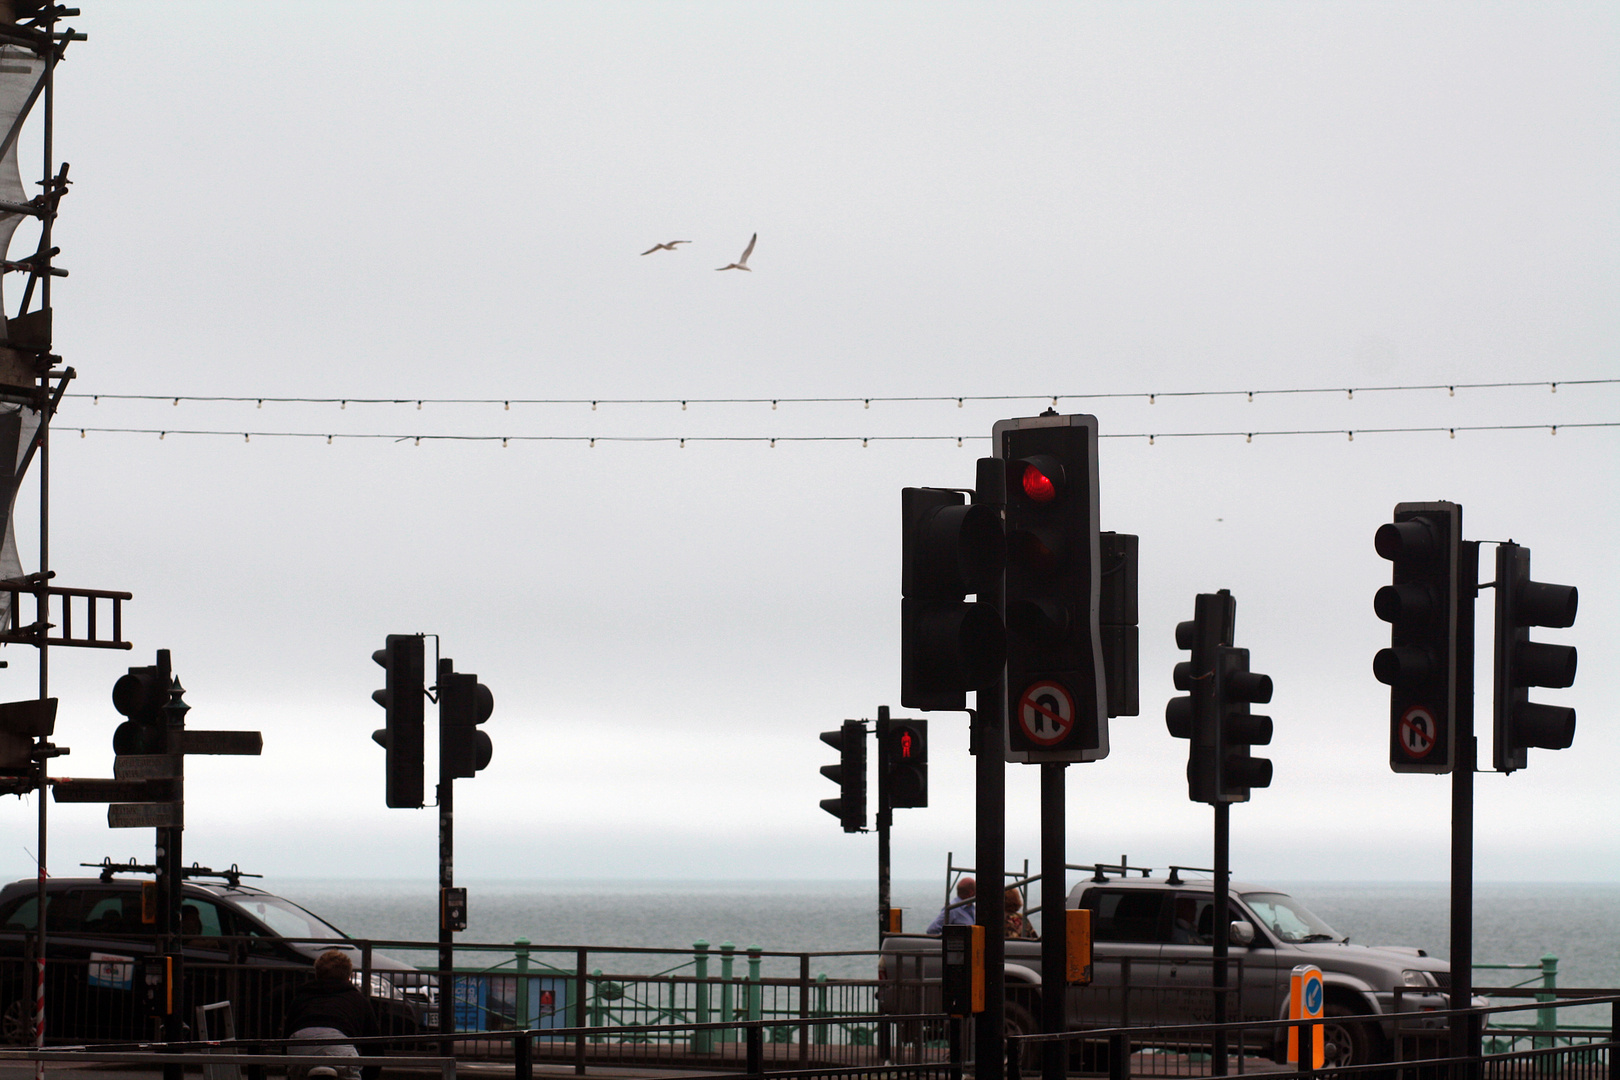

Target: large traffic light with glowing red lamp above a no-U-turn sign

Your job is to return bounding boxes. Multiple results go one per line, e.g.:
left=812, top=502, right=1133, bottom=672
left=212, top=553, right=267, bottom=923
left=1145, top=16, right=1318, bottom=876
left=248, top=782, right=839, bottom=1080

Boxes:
left=993, top=413, right=1124, bottom=761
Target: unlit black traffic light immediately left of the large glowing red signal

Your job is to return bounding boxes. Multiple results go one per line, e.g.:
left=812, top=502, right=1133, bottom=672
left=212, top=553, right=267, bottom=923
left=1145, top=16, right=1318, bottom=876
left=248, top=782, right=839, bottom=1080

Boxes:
left=901, top=487, right=1006, bottom=709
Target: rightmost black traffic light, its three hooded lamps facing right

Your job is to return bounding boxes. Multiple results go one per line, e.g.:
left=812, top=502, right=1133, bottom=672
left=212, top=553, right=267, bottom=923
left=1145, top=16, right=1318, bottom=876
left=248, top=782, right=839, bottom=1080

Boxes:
left=1492, top=542, right=1580, bottom=772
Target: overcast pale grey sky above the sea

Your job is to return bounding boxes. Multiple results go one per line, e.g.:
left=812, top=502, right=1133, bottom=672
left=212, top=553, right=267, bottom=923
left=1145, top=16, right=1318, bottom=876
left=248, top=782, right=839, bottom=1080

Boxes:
left=0, top=0, right=1620, bottom=887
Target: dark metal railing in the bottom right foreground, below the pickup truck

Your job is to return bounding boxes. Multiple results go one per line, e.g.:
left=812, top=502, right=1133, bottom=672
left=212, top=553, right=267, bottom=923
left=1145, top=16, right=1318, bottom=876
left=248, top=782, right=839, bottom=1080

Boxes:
left=1008, top=991, right=1620, bottom=1080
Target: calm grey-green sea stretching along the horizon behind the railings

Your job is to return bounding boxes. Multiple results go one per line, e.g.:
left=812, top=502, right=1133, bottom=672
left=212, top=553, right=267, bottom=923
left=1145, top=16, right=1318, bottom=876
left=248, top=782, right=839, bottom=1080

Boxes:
left=272, top=879, right=1620, bottom=986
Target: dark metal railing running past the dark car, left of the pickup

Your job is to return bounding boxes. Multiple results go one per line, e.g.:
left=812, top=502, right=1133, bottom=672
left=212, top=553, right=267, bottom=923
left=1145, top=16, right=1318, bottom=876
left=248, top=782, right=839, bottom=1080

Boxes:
left=0, top=938, right=876, bottom=1046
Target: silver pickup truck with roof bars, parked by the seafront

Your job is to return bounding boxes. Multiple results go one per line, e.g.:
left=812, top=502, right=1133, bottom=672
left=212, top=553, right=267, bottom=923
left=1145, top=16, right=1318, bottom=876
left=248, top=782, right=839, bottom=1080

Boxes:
left=878, top=871, right=1450, bottom=1065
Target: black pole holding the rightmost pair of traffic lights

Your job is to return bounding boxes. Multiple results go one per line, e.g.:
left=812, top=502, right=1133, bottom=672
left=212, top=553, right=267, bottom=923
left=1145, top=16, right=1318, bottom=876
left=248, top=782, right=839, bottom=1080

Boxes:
left=1452, top=541, right=1477, bottom=1059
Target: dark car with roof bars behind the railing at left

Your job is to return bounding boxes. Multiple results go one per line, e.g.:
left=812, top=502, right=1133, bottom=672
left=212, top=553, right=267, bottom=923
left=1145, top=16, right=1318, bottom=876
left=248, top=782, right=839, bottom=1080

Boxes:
left=0, top=863, right=437, bottom=1044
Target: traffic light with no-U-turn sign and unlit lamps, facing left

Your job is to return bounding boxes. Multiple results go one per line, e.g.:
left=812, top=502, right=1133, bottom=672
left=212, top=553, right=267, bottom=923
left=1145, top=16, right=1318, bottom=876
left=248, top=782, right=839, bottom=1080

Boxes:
left=1372, top=502, right=1474, bottom=772
